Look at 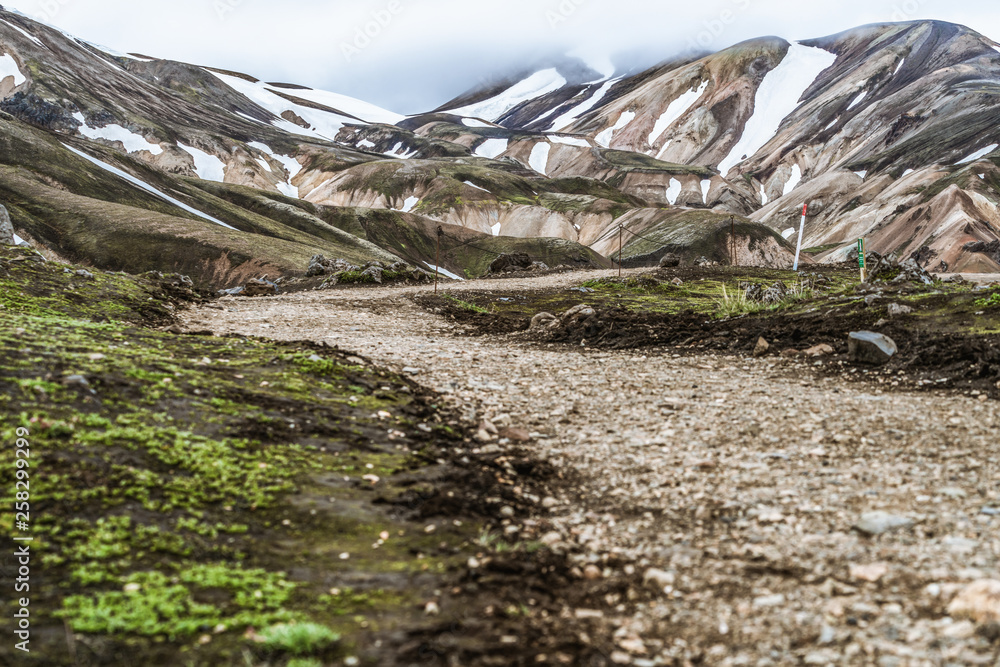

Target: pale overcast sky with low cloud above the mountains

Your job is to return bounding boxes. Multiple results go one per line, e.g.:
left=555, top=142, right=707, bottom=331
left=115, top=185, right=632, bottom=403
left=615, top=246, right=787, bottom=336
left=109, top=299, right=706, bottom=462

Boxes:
left=0, top=0, right=1000, bottom=113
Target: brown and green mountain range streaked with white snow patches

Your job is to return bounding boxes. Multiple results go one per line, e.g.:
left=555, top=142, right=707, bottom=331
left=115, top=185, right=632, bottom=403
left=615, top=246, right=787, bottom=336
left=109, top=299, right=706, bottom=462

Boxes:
left=0, top=11, right=1000, bottom=278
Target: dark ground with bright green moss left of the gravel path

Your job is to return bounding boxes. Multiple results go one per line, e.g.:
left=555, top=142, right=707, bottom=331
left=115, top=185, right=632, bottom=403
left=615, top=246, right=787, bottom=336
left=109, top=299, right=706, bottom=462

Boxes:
left=0, top=249, right=508, bottom=665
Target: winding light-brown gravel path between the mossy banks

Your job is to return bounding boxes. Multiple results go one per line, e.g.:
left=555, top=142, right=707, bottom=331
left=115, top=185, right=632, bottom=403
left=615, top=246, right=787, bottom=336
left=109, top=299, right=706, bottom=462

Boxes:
left=185, top=272, right=1000, bottom=666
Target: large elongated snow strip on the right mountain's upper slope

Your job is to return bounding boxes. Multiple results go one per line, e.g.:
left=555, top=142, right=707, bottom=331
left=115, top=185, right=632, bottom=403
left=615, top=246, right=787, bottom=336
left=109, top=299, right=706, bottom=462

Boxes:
left=719, top=43, right=837, bottom=175
